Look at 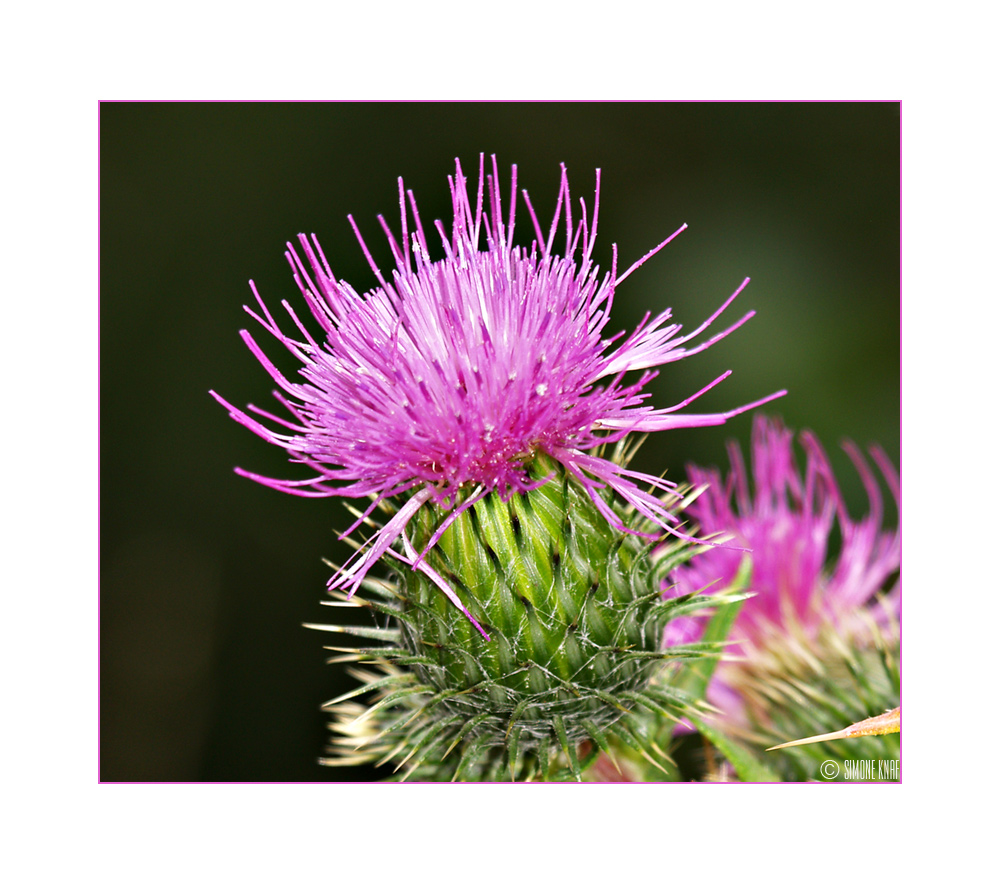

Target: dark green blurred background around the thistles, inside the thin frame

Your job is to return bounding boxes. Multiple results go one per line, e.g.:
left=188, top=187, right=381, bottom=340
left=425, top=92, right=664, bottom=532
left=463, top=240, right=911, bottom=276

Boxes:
left=100, top=102, right=900, bottom=781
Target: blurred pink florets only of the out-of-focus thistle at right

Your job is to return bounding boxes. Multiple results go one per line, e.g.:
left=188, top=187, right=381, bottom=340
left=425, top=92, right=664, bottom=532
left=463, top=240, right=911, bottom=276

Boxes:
left=665, top=417, right=901, bottom=711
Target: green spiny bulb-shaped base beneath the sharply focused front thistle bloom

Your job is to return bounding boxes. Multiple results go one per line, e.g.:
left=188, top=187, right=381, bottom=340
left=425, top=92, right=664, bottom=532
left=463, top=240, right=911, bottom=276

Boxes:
left=314, top=448, right=744, bottom=779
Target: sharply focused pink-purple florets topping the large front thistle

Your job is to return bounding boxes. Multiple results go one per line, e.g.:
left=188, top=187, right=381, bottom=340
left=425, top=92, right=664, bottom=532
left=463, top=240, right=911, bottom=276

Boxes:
left=212, top=156, right=784, bottom=622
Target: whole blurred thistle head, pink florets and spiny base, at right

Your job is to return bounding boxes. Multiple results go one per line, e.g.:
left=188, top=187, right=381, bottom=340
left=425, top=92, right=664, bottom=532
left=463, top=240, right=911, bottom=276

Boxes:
left=665, top=417, right=901, bottom=772
